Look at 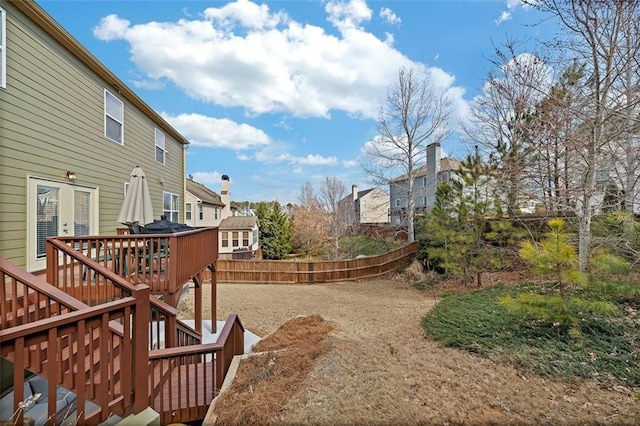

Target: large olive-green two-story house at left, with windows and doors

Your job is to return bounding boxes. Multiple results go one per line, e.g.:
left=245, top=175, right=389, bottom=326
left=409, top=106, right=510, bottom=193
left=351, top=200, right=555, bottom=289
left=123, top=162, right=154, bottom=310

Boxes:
left=0, top=0, right=188, bottom=271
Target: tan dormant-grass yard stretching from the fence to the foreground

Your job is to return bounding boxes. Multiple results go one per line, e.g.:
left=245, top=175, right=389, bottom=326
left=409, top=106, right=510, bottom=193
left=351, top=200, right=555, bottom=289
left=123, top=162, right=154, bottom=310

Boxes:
left=176, top=278, right=640, bottom=425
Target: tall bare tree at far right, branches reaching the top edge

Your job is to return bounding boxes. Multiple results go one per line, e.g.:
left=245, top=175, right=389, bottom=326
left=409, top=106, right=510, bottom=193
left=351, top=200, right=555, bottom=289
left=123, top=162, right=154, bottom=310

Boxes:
left=533, top=0, right=640, bottom=271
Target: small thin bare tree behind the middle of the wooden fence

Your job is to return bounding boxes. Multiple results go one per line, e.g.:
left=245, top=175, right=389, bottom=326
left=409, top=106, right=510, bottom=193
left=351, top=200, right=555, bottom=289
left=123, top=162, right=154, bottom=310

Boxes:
left=317, top=177, right=351, bottom=258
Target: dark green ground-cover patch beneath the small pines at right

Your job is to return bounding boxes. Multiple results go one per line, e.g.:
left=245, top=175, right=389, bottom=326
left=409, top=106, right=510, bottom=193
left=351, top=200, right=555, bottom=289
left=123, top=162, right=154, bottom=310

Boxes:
left=422, top=284, right=640, bottom=387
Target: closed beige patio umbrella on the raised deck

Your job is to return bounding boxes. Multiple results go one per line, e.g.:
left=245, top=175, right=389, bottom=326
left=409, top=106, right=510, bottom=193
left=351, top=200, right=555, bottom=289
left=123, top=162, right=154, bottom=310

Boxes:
left=118, top=166, right=153, bottom=226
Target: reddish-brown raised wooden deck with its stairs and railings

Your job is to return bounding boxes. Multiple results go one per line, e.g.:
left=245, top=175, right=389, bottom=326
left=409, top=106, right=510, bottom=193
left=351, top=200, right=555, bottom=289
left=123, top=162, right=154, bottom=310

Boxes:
left=0, top=228, right=244, bottom=425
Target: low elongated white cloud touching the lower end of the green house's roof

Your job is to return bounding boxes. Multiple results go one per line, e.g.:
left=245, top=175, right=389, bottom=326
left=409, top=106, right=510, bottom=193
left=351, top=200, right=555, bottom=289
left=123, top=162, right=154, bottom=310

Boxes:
left=160, top=112, right=271, bottom=150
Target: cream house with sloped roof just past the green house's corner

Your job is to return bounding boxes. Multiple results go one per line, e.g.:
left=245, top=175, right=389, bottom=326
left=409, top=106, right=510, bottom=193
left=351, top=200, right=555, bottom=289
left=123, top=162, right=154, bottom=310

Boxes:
left=184, top=176, right=225, bottom=227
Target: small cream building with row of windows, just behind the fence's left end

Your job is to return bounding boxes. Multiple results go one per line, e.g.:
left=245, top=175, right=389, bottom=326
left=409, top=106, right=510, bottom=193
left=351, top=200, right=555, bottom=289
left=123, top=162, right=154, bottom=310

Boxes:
left=218, top=216, right=260, bottom=259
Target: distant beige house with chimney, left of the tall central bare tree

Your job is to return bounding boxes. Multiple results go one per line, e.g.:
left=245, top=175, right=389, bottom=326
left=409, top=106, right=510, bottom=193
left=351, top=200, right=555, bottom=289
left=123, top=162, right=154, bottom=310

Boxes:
left=340, top=185, right=389, bottom=225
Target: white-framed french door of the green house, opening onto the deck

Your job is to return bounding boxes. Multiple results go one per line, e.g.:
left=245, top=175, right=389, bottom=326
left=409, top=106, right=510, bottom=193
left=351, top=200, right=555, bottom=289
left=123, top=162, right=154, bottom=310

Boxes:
left=27, top=178, right=98, bottom=271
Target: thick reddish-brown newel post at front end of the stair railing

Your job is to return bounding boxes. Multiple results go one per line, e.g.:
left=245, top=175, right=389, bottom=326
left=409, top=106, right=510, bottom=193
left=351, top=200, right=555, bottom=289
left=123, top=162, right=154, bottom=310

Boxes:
left=133, top=284, right=151, bottom=414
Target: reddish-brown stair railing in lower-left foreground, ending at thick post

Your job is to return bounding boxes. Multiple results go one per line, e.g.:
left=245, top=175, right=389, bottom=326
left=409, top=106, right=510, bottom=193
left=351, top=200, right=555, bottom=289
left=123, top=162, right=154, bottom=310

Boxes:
left=0, top=259, right=150, bottom=424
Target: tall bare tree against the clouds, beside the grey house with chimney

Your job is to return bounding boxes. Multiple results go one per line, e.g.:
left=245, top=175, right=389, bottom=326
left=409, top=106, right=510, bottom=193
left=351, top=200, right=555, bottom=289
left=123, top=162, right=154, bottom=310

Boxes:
left=362, top=68, right=449, bottom=241
